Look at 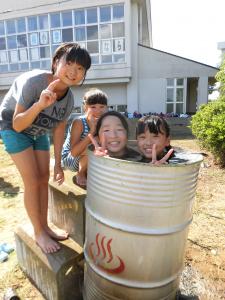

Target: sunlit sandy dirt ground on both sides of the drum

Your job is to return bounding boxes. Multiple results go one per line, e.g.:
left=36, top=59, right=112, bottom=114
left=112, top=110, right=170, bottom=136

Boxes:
left=0, top=139, right=225, bottom=300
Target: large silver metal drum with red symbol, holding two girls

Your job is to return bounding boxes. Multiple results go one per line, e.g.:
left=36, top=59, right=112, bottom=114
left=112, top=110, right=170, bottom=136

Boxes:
left=83, top=151, right=202, bottom=300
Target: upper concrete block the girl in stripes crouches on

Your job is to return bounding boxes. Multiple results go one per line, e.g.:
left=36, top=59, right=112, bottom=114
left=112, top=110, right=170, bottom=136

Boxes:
left=49, top=170, right=86, bottom=247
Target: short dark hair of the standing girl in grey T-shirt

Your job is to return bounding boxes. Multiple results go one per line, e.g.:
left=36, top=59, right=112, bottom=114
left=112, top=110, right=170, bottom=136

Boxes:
left=51, top=43, right=91, bottom=77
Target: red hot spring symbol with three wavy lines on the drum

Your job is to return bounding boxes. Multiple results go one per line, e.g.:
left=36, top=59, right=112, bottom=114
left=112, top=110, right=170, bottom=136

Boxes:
left=88, top=233, right=125, bottom=274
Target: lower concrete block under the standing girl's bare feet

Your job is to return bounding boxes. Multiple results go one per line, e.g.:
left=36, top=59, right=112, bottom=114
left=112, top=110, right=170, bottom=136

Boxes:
left=15, top=225, right=83, bottom=300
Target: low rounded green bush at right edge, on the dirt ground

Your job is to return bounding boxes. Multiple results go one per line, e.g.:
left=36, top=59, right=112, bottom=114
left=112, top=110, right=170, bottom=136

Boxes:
left=191, top=101, right=225, bottom=167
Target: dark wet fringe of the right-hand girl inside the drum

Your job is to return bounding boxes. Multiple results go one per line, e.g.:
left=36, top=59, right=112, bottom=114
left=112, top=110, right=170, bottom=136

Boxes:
left=136, top=116, right=170, bottom=137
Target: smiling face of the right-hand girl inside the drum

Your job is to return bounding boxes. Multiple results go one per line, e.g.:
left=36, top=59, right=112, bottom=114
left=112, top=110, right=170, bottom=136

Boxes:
left=137, top=128, right=170, bottom=158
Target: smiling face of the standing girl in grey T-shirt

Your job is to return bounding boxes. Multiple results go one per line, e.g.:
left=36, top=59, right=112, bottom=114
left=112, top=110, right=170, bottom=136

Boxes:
left=54, top=57, right=86, bottom=86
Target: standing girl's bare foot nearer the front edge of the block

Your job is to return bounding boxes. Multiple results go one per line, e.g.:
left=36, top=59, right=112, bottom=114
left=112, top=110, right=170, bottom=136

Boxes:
left=35, top=231, right=60, bottom=254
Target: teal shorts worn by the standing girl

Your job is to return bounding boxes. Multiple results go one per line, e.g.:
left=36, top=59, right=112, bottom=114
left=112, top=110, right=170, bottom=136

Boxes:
left=0, top=130, right=50, bottom=154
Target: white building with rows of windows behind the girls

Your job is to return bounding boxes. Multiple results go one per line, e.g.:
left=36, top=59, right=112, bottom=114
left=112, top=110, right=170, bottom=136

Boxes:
left=0, top=0, right=218, bottom=113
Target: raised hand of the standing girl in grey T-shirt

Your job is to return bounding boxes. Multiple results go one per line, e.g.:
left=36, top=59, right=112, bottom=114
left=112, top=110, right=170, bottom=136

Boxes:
left=38, top=79, right=60, bottom=109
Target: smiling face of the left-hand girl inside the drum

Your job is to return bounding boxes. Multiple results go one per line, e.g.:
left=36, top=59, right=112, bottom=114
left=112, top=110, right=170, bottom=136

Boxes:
left=99, top=115, right=127, bottom=157
